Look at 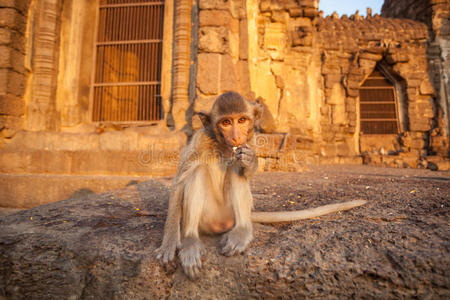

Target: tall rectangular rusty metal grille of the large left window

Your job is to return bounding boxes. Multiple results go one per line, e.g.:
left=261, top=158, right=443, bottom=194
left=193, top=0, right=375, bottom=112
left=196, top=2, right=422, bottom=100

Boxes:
left=92, top=0, right=164, bottom=122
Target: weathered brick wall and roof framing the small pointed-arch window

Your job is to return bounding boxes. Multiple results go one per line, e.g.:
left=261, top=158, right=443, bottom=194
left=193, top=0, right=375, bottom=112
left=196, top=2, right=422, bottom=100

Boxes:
left=317, top=16, right=434, bottom=156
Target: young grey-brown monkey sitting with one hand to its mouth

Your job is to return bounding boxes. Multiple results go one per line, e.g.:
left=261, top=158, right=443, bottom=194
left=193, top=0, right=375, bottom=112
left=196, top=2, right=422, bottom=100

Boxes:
left=155, top=92, right=365, bottom=279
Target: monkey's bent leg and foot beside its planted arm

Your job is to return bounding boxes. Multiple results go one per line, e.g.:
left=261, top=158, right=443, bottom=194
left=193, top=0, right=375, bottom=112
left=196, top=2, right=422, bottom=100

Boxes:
left=178, top=166, right=211, bottom=279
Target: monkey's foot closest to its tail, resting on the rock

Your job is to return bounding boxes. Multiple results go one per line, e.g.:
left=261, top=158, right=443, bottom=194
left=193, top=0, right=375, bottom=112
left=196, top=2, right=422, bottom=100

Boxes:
left=220, top=227, right=253, bottom=256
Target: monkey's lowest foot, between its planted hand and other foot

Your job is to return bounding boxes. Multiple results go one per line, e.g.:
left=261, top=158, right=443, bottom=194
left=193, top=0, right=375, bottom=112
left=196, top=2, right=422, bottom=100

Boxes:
left=178, top=237, right=204, bottom=279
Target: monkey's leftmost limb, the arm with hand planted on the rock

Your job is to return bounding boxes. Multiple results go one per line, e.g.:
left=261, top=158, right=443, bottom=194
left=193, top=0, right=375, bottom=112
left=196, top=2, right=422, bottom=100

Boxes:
left=155, top=182, right=183, bottom=264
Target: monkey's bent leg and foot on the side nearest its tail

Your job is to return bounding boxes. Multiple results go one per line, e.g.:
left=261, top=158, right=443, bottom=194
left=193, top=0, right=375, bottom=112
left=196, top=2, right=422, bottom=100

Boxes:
left=221, top=170, right=253, bottom=256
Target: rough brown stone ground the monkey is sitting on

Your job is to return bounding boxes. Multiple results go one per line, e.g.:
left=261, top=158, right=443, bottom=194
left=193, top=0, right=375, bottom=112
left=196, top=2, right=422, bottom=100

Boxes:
left=0, top=165, right=450, bottom=299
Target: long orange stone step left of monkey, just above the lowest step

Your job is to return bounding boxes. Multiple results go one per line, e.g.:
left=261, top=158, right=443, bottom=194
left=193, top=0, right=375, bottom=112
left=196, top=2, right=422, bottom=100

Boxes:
left=0, top=148, right=179, bottom=176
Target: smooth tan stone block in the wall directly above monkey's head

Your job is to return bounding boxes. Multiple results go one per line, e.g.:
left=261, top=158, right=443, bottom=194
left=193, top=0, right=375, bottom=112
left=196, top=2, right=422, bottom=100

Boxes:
left=197, top=53, right=221, bottom=95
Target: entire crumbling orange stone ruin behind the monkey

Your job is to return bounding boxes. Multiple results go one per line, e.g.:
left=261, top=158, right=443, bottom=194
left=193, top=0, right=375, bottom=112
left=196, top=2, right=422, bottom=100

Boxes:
left=0, top=0, right=450, bottom=207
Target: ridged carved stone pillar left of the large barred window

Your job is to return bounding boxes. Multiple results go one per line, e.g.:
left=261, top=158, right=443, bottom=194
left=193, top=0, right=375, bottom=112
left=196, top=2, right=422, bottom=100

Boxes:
left=26, top=0, right=61, bottom=131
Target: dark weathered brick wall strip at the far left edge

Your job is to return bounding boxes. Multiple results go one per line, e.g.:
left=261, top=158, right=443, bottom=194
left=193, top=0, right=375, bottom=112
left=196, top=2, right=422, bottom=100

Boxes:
left=0, top=0, right=30, bottom=145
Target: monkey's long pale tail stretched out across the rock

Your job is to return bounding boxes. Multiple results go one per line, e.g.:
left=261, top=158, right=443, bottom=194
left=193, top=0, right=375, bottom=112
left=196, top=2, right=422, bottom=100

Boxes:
left=252, top=200, right=367, bottom=223
